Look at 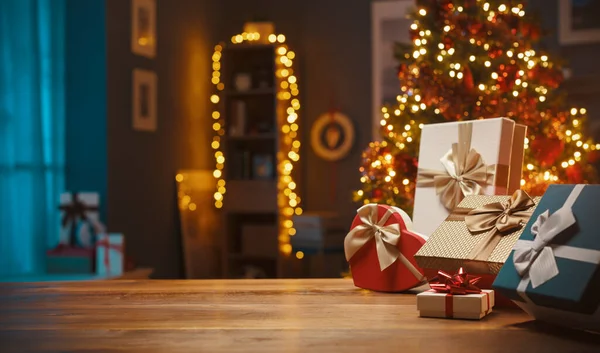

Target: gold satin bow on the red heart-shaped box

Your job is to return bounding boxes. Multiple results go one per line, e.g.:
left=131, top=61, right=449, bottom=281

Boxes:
left=344, top=204, right=400, bottom=271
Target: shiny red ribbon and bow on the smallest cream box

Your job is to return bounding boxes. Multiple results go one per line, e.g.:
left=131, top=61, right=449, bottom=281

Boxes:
left=429, top=267, right=491, bottom=318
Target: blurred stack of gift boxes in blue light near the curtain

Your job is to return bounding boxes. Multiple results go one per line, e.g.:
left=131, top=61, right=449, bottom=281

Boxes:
left=46, top=192, right=125, bottom=277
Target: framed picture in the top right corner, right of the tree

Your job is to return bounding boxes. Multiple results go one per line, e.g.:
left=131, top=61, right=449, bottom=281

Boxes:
left=558, top=0, right=600, bottom=45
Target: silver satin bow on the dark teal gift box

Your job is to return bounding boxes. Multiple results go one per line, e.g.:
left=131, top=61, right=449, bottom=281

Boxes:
left=513, top=205, right=576, bottom=288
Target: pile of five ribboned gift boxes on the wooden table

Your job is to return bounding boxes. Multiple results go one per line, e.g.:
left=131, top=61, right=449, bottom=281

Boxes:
left=344, top=118, right=600, bottom=331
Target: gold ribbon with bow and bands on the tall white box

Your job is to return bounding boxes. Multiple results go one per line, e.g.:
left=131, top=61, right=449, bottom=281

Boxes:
left=417, top=123, right=508, bottom=210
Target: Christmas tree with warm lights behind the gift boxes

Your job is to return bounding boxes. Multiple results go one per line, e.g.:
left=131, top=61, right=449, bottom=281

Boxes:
left=354, top=0, right=600, bottom=211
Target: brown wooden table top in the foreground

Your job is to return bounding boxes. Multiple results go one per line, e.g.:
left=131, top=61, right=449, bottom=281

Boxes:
left=0, top=279, right=600, bottom=353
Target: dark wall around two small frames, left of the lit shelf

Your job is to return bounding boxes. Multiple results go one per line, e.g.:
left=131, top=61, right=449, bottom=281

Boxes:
left=106, top=0, right=220, bottom=278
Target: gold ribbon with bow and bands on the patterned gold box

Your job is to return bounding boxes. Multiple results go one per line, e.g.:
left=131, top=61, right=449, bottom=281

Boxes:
left=446, top=190, right=535, bottom=261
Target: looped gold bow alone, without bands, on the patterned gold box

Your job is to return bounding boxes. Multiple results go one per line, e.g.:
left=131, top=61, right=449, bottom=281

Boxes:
left=465, top=190, right=535, bottom=234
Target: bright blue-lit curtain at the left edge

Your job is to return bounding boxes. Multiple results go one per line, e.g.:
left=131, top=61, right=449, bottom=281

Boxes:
left=0, top=0, right=65, bottom=276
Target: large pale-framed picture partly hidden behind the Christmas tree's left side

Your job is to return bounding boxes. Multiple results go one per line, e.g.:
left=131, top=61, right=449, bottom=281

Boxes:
left=371, top=0, right=414, bottom=141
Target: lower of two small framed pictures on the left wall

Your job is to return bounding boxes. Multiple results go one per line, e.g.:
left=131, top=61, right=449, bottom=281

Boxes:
left=132, top=69, right=157, bottom=131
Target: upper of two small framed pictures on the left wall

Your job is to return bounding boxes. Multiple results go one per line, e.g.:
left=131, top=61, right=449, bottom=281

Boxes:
left=131, top=0, right=156, bottom=58
